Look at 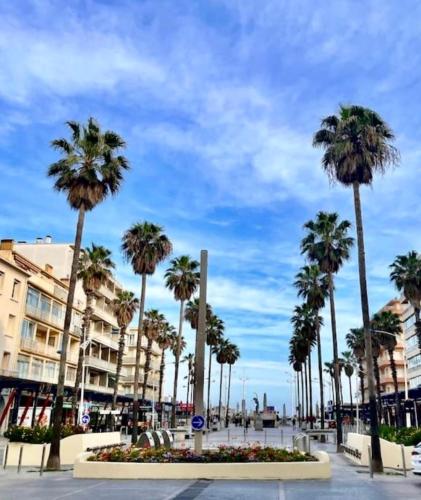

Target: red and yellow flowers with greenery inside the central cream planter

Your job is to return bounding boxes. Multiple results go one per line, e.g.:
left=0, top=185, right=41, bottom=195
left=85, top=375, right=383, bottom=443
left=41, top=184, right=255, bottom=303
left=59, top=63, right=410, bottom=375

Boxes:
left=88, top=446, right=317, bottom=464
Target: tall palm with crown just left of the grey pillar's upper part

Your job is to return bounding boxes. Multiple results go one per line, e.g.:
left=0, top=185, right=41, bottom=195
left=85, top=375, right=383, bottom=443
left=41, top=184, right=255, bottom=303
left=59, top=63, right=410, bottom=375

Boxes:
left=165, top=255, right=200, bottom=427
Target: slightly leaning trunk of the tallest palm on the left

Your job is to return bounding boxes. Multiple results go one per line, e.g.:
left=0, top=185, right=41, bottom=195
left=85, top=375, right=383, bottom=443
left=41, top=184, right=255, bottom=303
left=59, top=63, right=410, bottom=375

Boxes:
left=47, top=205, right=85, bottom=470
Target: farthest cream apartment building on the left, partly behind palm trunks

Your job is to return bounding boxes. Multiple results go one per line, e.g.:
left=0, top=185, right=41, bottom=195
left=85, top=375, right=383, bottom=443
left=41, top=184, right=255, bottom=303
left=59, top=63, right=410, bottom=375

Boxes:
left=120, top=328, right=162, bottom=401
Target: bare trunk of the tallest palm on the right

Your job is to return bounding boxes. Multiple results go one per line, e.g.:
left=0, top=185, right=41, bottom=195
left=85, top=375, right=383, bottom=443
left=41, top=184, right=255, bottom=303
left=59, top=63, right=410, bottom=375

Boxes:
left=353, top=182, right=383, bottom=472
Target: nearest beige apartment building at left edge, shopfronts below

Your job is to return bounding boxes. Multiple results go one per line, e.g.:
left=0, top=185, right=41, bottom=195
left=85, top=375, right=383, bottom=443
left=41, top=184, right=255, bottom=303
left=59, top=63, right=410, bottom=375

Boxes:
left=0, top=240, right=82, bottom=427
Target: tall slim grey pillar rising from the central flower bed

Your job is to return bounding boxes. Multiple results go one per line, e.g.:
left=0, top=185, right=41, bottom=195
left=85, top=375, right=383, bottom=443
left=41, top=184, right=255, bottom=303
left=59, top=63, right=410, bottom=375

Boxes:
left=192, top=250, right=208, bottom=455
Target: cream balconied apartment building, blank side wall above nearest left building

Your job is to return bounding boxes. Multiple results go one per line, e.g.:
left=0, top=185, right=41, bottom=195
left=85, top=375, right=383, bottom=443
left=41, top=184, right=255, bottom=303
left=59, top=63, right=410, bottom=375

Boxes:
left=15, top=236, right=125, bottom=399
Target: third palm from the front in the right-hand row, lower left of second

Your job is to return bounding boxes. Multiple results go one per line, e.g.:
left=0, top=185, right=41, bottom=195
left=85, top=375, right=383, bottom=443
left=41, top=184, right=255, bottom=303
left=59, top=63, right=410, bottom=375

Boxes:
left=294, top=264, right=329, bottom=429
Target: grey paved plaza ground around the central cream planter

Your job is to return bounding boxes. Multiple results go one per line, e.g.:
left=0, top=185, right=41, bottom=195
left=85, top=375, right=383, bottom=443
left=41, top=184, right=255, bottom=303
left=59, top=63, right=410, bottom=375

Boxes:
left=0, top=427, right=421, bottom=500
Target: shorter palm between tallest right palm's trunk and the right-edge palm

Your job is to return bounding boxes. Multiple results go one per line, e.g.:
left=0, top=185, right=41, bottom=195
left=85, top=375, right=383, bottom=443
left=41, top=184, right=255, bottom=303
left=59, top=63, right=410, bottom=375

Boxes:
left=371, top=311, right=402, bottom=427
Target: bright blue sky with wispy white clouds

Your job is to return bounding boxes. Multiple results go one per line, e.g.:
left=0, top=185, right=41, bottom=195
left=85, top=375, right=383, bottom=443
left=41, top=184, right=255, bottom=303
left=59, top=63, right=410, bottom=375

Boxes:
left=0, top=0, right=421, bottom=407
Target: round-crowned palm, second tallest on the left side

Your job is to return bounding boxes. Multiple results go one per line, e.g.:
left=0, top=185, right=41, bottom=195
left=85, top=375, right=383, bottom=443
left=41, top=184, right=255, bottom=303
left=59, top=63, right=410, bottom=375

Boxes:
left=121, top=221, right=172, bottom=444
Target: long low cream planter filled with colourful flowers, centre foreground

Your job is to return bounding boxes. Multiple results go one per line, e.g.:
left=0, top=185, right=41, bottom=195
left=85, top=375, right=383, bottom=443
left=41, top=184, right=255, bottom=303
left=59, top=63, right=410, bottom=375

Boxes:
left=73, top=446, right=331, bottom=480
